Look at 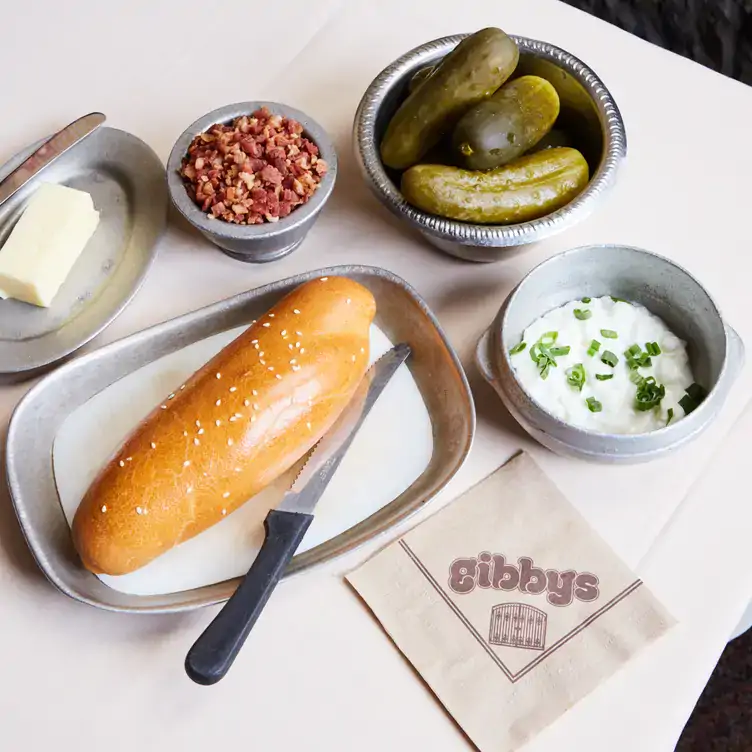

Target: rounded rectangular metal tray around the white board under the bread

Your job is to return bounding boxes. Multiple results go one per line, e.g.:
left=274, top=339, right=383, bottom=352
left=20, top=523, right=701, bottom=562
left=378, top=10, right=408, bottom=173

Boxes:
left=6, top=266, right=475, bottom=613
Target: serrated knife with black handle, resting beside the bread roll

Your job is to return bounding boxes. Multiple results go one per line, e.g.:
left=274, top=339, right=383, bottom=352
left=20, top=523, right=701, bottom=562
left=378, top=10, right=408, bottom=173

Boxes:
left=185, top=344, right=410, bottom=685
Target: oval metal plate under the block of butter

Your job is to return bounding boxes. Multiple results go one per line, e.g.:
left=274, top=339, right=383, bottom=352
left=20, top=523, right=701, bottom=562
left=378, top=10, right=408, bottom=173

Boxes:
left=0, top=128, right=168, bottom=380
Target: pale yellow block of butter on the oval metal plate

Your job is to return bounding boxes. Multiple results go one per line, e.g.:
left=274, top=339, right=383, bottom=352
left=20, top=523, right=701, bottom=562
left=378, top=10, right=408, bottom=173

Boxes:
left=0, top=183, right=99, bottom=308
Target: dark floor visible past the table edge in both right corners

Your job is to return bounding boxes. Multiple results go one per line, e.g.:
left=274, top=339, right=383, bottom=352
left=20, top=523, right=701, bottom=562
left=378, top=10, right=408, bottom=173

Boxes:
left=564, top=0, right=752, bottom=752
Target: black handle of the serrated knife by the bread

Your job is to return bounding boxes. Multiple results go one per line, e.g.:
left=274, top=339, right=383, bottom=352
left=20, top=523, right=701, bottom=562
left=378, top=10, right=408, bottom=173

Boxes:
left=185, top=509, right=313, bottom=685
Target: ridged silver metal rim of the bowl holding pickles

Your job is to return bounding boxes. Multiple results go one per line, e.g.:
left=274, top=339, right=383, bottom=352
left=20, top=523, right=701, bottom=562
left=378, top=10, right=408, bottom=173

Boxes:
left=353, top=34, right=627, bottom=247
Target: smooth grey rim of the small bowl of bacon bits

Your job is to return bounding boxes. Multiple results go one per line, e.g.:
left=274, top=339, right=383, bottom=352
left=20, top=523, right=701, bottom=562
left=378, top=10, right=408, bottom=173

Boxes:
left=167, top=100, right=337, bottom=241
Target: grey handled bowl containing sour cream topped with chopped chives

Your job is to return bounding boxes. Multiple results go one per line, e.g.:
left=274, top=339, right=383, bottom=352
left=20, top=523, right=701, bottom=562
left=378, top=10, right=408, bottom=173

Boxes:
left=476, top=245, right=744, bottom=463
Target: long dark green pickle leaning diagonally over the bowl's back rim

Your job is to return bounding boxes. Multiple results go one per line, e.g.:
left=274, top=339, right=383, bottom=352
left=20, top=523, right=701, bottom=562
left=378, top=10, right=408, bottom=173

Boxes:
left=381, top=28, right=519, bottom=170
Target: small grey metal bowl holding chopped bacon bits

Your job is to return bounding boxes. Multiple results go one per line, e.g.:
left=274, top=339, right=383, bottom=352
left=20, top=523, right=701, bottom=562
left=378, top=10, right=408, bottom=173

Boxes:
left=167, top=102, right=337, bottom=263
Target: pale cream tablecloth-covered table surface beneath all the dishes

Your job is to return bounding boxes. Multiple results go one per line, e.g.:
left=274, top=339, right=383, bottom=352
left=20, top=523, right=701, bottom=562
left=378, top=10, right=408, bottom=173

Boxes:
left=0, top=0, right=752, bottom=752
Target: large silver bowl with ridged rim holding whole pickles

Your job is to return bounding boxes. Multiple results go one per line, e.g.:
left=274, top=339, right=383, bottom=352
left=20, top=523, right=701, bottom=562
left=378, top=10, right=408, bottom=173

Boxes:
left=353, top=34, right=627, bottom=261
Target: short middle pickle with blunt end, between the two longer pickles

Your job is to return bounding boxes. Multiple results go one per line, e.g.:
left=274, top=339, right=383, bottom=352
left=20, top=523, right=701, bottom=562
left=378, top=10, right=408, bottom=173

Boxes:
left=452, top=76, right=559, bottom=170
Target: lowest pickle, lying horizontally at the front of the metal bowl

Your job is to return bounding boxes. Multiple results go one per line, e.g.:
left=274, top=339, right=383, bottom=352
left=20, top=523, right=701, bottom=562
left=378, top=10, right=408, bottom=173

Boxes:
left=401, top=147, right=589, bottom=224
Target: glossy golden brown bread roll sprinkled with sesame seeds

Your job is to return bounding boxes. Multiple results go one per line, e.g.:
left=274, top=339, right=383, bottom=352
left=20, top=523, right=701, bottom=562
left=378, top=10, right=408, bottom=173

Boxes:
left=73, top=277, right=376, bottom=575
